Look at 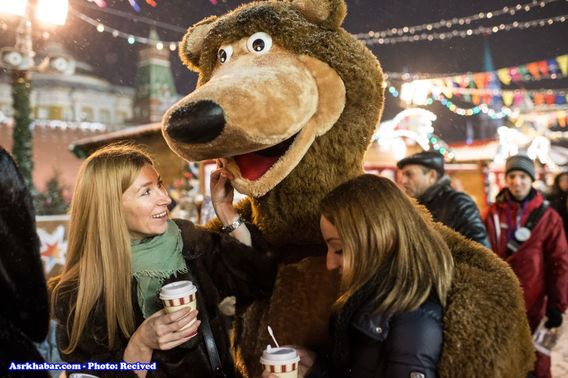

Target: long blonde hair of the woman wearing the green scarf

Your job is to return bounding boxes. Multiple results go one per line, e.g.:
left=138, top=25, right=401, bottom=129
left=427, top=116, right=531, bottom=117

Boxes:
left=49, top=145, right=153, bottom=354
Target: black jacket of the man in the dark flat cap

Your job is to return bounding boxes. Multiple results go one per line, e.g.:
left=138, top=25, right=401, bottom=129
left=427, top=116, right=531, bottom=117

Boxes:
left=417, top=176, right=491, bottom=248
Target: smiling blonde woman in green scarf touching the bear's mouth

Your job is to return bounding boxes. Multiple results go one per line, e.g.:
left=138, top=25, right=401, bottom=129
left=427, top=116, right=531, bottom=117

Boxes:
left=50, top=145, right=275, bottom=377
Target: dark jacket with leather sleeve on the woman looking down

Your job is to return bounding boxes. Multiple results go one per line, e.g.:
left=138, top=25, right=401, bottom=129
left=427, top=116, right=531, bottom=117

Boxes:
left=308, top=276, right=443, bottom=378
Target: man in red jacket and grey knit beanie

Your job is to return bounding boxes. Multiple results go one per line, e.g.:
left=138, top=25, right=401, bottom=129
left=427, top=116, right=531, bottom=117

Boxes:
left=485, top=155, right=568, bottom=378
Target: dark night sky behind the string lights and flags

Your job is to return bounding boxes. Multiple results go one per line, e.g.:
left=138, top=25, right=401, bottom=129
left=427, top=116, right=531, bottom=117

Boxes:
left=0, top=0, right=568, bottom=141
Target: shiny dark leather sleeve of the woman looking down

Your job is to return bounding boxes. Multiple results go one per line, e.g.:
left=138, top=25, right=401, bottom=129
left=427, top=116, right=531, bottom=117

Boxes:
left=384, top=311, right=443, bottom=378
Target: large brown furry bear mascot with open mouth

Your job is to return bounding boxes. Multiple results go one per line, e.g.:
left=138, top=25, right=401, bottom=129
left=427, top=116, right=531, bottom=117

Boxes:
left=162, top=0, right=534, bottom=377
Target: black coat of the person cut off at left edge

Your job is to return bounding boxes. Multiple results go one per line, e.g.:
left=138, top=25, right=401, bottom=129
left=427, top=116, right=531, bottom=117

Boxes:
left=0, top=147, right=49, bottom=377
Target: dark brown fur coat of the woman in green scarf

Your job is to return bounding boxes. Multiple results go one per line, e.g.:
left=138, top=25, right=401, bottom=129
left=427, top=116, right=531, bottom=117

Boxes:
left=56, top=220, right=276, bottom=378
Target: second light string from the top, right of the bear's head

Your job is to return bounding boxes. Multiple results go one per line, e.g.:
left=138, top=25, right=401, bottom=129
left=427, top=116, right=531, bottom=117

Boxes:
left=360, top=15, right=568, bottom=45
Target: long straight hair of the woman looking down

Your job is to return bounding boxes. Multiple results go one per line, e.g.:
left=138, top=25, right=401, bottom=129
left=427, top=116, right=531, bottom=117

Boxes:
left=321, top=174, right=454, bottom=314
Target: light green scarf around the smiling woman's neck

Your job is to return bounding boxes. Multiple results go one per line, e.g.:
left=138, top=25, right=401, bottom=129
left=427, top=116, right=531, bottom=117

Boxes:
left=131, top=220, right=187, bottom=318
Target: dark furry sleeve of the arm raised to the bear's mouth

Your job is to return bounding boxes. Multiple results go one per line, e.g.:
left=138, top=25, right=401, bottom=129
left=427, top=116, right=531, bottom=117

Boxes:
left=176, top=220, right=277, bottom=306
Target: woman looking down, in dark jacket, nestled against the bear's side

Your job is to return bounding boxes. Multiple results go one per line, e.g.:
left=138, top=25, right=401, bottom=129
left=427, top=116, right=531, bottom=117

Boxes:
left=264, top=175, right=453, bottom=378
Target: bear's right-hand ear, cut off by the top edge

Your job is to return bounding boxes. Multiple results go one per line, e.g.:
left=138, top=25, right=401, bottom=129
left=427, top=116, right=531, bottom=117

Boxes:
left=290, top=0, right=347, bottom=29
